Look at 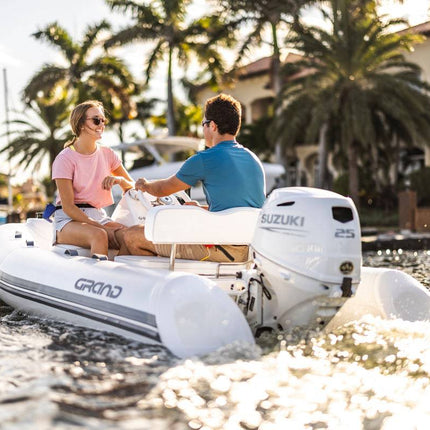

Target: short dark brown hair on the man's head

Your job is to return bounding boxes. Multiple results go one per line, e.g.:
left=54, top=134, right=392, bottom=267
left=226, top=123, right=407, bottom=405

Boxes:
left=205, top=94, right=242, bottom=136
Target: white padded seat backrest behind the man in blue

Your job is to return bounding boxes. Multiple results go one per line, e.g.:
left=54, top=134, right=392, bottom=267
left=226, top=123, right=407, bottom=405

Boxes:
left=145, top=206, right=261, bottom=245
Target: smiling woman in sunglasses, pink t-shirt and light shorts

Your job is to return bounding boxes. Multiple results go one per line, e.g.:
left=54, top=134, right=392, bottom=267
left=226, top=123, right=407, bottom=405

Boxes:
left=52, top=100, right=134, bottom=255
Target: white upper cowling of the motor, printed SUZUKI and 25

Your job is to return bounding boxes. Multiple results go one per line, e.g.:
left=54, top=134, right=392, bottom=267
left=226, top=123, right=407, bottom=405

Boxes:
left=252, top=187, right=361, bottom=284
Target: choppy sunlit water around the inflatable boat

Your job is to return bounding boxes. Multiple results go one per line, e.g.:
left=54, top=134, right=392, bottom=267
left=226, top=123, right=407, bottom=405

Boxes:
left=0, top=251, right=430, bottom=430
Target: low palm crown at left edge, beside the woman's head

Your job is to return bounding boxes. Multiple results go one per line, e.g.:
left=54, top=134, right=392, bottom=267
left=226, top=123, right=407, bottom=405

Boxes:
left=0, top=97, right=71, bottom=186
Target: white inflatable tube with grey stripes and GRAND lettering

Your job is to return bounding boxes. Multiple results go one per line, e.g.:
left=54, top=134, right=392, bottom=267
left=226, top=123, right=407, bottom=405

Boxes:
left=0, top=247, right=254, bottom=358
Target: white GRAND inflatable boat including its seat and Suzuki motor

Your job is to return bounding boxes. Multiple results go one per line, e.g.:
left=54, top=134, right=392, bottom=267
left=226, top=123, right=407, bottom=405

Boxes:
left=0, top=187, right=430, bottom=358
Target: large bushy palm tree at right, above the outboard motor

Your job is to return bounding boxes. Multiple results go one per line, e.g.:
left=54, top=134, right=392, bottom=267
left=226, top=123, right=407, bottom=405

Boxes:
left=275, top=0, right=430, bottom=205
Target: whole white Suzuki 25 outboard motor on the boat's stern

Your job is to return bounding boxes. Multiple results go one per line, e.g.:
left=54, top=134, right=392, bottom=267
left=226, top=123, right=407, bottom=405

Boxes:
left=241, top=187, right=361, bottom=334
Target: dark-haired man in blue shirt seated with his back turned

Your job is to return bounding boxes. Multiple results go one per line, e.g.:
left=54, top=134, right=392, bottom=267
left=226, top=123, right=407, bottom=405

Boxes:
left=118, top=94, right=265, bottom=262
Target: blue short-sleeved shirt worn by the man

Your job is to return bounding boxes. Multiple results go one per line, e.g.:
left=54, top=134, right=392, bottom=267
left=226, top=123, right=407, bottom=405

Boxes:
left=176, top=140, right=266, bottom=212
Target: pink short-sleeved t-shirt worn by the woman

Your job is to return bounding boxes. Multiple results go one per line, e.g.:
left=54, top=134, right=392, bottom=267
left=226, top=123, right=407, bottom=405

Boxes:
left=52, top=145, right=121, bottom=208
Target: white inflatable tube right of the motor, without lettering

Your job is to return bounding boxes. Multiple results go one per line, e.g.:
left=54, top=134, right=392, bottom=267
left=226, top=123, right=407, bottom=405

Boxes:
left=326, top=267, right=430, bottom=330
